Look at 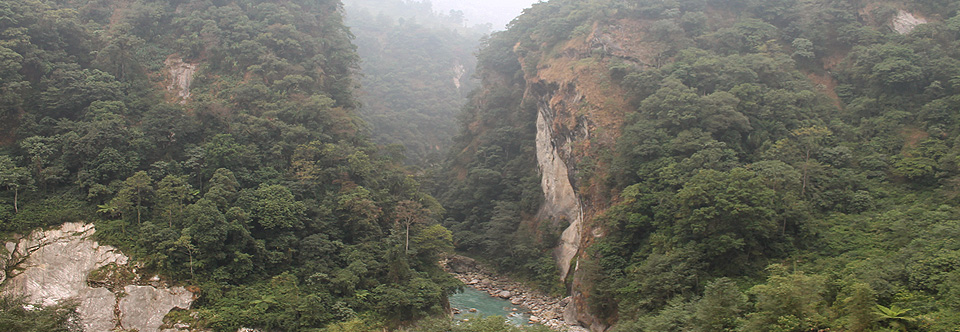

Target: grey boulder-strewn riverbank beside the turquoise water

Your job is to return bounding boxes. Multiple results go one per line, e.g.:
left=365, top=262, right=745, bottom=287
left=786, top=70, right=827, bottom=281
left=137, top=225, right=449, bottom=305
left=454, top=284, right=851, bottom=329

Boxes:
left=440, top=255, right=589, bottom=332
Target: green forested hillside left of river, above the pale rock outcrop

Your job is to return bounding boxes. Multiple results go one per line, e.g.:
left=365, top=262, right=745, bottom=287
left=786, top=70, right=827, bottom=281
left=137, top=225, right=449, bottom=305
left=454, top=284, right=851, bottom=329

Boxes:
left=0, top=0, right=459, bottom=331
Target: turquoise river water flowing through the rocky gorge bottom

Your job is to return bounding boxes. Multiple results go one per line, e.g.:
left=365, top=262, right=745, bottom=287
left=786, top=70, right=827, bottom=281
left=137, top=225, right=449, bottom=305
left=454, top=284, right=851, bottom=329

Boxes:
left=450, top=287, right=530, bottom=325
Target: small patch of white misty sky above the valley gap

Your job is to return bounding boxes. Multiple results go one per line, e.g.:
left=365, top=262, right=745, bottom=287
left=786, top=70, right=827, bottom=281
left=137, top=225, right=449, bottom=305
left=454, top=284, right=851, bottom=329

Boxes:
left=430, top=0, right=538, bottom=30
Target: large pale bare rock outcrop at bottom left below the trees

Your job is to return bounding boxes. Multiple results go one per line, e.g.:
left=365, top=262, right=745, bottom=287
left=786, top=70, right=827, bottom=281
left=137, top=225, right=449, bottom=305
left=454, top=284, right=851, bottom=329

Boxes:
left=0, top=223, right=193, bottom=332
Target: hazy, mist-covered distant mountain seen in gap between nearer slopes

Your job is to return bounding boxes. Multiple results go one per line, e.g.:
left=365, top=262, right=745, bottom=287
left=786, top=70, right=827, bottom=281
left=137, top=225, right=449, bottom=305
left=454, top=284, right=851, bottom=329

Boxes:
left=345, top=0, right=489, bottom=166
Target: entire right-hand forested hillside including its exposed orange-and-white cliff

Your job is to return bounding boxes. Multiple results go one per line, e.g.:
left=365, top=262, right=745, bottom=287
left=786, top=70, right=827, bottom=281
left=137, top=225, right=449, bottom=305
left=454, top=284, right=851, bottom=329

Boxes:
left=441, top=0, right=960, bottom=332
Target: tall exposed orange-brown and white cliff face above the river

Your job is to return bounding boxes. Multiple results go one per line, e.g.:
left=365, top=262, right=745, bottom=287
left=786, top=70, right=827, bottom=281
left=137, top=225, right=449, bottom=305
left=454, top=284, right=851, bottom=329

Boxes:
left=520, top=20, right=651, bottom=270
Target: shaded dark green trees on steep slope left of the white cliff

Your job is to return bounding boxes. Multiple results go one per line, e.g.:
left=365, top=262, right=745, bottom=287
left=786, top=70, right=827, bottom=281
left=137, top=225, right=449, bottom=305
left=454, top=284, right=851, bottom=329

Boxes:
left=435, top=43, right=548, bottom=282
